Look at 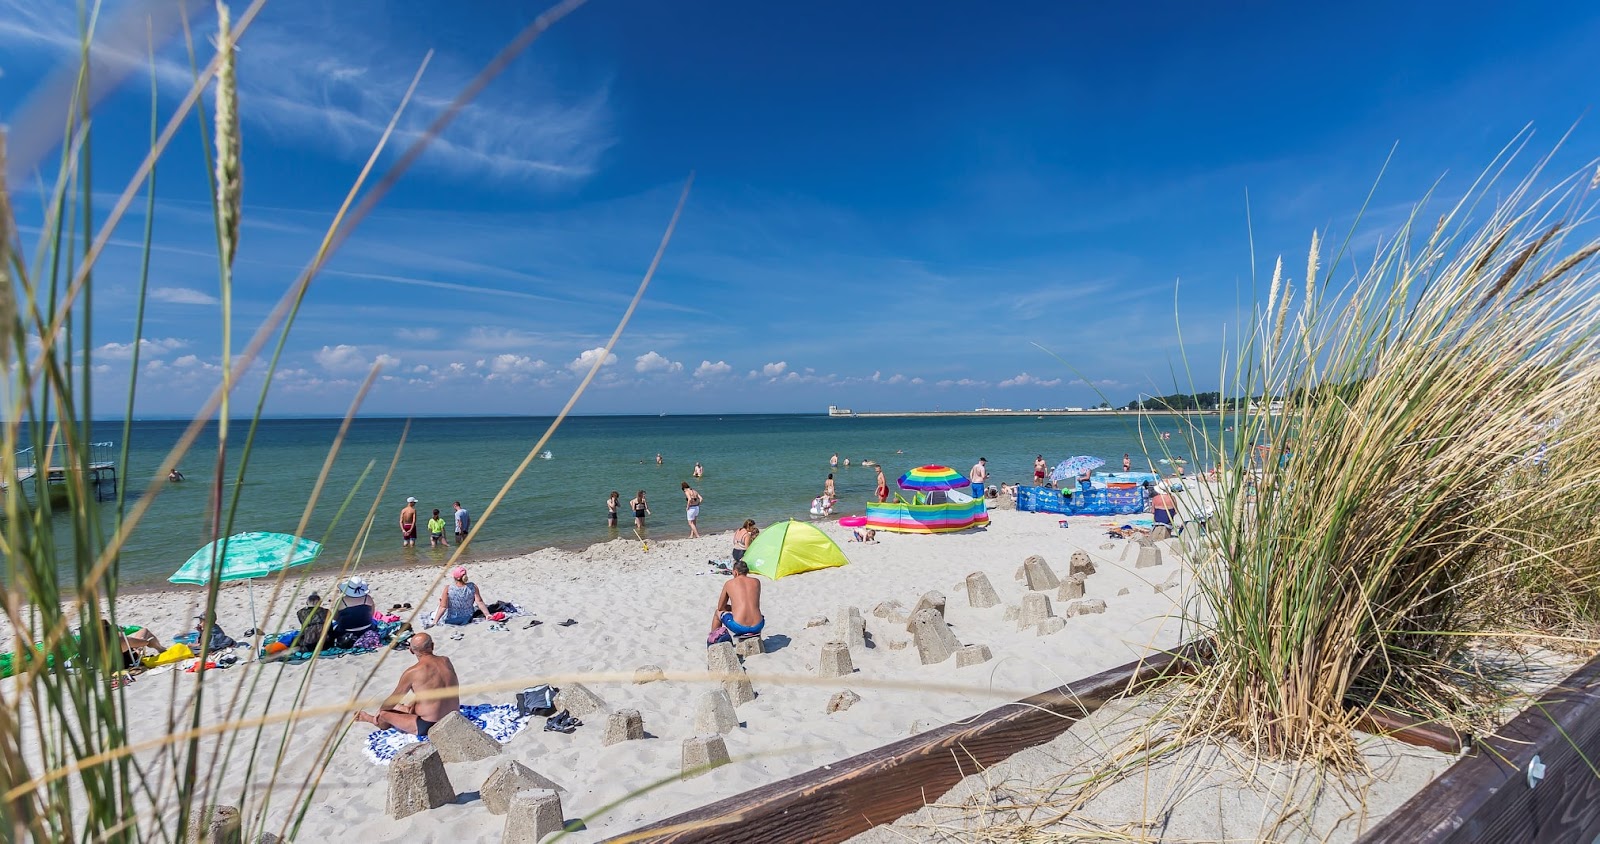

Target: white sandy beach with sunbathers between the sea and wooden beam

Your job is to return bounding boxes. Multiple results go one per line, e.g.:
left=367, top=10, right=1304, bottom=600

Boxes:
left=9, top=510, right=1182, bottom=842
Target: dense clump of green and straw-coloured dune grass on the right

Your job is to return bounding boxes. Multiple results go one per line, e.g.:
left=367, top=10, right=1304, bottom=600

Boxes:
left=1164, top=155, right=1600, bottom=767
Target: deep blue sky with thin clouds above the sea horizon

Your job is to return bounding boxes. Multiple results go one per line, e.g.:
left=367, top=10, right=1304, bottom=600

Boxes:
left=0, top=0, right=1600, bottom=416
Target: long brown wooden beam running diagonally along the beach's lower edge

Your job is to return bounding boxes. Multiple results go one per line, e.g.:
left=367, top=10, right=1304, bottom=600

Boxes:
left=610, top=646, right=1200, bottom=844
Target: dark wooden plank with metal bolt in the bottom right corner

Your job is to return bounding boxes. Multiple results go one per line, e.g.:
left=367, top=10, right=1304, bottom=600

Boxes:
left=1362, top=659, right=1600, bottom=844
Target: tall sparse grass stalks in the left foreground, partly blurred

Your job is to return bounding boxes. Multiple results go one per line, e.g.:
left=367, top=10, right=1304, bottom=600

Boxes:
left=0, top=0, right=604, bottom=841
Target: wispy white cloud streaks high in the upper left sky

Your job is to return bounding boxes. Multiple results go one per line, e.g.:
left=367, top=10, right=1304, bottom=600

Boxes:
left=0, top=0, right=614, bottom=185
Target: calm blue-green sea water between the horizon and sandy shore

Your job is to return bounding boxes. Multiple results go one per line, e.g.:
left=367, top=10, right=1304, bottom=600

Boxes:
left=28, top=416, right=1219, bottom=585
